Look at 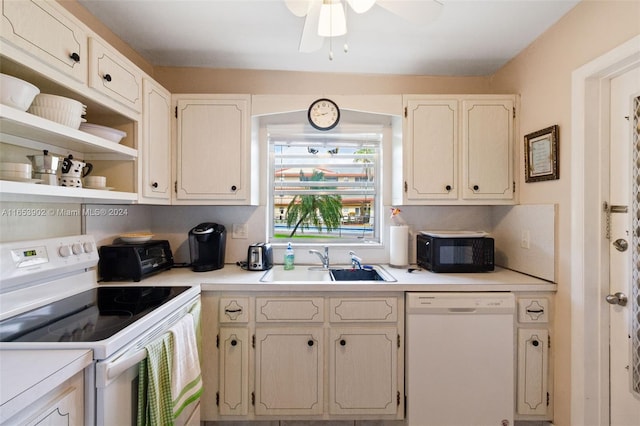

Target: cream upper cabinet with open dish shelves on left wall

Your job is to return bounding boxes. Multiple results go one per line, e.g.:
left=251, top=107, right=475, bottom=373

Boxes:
left=0, top=0, right=149, bottom=203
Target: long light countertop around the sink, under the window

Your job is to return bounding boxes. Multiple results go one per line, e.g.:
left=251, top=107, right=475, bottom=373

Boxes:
left=117, top=264, right=557, bottom=292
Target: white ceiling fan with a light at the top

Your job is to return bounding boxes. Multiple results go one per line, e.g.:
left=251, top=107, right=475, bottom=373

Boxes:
left=284, top=0, right=442, bottom=54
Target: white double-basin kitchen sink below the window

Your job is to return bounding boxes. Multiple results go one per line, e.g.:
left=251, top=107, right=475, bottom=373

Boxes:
left=260, top=265, right=396, bottom=283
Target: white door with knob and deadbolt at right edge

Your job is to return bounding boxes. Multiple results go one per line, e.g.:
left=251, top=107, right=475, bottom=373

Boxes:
left=607, top=68, right=640, bottom=426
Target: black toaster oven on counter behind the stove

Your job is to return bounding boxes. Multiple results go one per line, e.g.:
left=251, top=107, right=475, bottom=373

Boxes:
left=98, top=240, right=173, bottom=281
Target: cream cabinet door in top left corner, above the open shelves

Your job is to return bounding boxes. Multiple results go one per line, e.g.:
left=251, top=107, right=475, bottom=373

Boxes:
left=0, top=0, right=89, bottom=83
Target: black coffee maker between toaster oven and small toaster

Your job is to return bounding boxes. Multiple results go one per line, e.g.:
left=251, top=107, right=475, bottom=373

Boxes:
left=189, top=222, right=227, bottom=272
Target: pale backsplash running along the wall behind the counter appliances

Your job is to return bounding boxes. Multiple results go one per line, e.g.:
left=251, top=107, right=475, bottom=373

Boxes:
left=0, top=202, right=556, bottom=282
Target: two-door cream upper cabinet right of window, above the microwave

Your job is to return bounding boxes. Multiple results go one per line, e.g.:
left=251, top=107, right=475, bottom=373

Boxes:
left=394, top=95, right=516, bottom=205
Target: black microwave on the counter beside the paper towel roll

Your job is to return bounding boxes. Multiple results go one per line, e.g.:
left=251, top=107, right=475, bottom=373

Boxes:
left=416, top=231, right=495, bottom=272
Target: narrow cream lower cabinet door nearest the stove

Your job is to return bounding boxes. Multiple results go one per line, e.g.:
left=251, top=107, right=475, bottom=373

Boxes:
left=218, top=327, right=251, bottom=416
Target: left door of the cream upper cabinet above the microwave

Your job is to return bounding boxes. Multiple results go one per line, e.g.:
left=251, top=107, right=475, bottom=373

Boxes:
left=403, top=99, right=458, bottom=204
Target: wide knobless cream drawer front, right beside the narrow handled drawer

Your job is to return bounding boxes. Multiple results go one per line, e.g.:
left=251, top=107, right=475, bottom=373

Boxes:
left=256, top=297, right=324, bottom=322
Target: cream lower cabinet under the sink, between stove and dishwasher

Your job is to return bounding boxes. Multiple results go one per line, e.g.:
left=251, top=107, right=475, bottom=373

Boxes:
left=202, top=292, right=404, bottom=421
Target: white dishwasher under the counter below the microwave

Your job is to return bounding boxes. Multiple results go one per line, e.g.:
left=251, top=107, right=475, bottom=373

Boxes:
left=405, top=292, right=515, bottom=426
